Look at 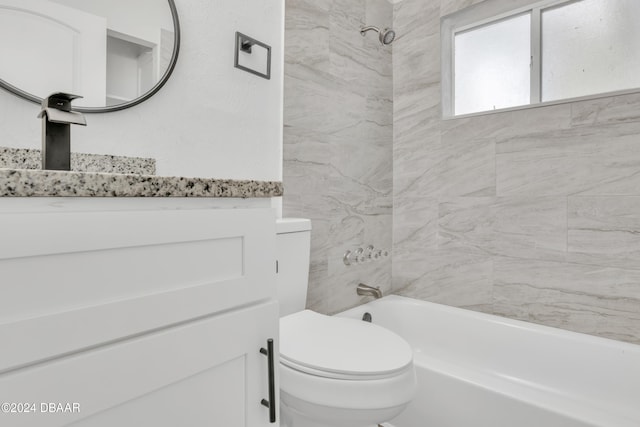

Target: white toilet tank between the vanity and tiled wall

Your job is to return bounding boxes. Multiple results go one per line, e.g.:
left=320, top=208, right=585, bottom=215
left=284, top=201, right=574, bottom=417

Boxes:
left=276, top=218, right=311, bottom=317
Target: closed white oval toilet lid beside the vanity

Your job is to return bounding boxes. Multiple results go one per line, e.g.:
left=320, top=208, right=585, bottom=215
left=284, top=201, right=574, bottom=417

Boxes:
left=280, top=310, right=413, bottom=379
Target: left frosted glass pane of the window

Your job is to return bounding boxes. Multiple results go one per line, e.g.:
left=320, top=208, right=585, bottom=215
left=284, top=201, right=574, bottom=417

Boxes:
left=454, top=14, right=528, bottom=115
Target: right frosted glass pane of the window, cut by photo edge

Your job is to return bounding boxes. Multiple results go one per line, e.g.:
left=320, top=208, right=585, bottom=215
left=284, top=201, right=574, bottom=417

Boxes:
left=542, top=0, right=640, bottom=101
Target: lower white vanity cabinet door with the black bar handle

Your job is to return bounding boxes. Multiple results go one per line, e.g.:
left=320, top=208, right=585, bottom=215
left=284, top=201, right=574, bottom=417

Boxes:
left=0, top=301, right=279, bottom=427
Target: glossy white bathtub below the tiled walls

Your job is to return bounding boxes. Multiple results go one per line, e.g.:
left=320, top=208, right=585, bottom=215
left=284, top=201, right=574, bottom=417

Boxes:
left=339, top=296, right=640, bottom=427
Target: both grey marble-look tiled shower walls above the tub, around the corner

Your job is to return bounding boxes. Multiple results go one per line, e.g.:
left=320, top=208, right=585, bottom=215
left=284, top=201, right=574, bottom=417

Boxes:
left=284, top=0, right=640, bottom=343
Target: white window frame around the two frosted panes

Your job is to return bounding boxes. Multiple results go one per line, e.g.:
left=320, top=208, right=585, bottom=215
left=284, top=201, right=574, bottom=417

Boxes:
left=440, top=0, right=640, bottom=119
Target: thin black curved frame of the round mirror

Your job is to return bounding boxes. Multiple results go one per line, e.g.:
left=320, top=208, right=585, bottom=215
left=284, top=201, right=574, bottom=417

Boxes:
left=0, top=0, right=180, bottom=113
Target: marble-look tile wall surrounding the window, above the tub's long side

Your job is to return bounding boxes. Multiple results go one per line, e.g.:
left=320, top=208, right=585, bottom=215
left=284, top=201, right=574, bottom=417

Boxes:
left=392, top=0, right=640, bottom=343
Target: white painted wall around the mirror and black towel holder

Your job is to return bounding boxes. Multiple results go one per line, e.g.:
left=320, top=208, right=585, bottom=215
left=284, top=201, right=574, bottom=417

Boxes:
left=0, top=0, right=284, bottom=180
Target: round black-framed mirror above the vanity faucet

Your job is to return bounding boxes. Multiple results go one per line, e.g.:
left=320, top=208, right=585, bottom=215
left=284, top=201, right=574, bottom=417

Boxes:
left=0, top=0, right=180, bottom=113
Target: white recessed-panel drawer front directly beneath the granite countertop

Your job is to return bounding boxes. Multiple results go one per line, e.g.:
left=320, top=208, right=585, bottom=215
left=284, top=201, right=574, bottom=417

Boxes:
left=0, top=209, right=276, bottom=376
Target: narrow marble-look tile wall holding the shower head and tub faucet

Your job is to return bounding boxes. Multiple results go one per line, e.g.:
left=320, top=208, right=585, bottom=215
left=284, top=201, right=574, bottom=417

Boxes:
left=283, top=0, right=393, bottom=313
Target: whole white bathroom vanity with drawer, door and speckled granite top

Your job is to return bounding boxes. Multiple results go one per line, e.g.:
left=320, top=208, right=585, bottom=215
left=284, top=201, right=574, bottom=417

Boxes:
left=0, top=170, right=282, bottom=427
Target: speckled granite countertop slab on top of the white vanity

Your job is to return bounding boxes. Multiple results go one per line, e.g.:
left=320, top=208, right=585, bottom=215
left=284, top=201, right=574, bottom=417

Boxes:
left=0, top=169, right=283, bottom=198
